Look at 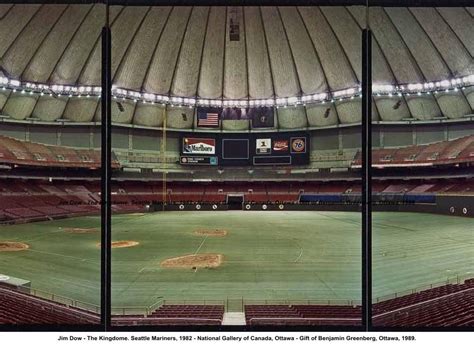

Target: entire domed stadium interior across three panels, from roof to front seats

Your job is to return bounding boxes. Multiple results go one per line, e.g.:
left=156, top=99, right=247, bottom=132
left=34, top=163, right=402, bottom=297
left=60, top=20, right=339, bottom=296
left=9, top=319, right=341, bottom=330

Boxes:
left=0, top=3, right=474, bottom=329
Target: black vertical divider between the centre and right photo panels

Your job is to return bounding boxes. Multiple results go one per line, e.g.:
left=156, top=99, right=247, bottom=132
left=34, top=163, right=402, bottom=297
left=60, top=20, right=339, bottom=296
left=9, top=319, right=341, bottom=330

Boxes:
left=362, top=29, right=372, bottom=330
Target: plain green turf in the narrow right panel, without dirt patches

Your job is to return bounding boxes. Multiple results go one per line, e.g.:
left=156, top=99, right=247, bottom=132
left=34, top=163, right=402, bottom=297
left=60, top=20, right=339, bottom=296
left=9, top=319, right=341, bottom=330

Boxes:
left=372, top=212, right=474, bottom=302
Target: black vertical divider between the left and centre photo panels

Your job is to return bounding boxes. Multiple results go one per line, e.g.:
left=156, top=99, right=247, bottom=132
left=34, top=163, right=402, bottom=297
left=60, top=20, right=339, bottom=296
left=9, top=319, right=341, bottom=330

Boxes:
left=100, top=5, right=112, bottom=330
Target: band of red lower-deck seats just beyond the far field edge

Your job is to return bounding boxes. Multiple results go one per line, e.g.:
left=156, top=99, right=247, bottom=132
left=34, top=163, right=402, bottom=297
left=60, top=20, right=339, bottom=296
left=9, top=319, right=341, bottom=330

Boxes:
left=0, top=179, right=474, bottom=222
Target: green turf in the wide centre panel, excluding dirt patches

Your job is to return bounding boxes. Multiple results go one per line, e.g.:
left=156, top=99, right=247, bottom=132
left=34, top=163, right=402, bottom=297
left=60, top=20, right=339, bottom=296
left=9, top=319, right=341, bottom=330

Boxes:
left=112, top=211, right=361, bottom=306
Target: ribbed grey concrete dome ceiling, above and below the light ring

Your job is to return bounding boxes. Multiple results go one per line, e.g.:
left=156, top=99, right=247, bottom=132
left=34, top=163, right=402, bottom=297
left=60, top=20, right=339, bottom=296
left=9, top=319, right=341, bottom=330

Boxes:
left=0, top=5, right=474, bottom=128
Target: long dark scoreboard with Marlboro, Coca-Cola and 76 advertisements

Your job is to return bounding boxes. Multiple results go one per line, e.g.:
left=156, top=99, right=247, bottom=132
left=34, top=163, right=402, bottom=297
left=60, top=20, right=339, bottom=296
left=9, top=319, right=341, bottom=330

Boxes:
left=180, top=132, right=310, bottom=166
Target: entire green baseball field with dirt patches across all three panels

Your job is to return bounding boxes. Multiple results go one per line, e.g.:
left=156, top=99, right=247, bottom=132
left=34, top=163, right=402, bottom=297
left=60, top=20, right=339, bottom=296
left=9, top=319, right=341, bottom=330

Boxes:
left=0, top=211, right=474, bottom=308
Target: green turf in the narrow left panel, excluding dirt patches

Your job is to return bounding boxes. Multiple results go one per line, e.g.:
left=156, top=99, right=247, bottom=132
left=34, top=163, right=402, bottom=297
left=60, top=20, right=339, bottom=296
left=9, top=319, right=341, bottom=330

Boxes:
left=0, top=217, right=100, bottom=305
